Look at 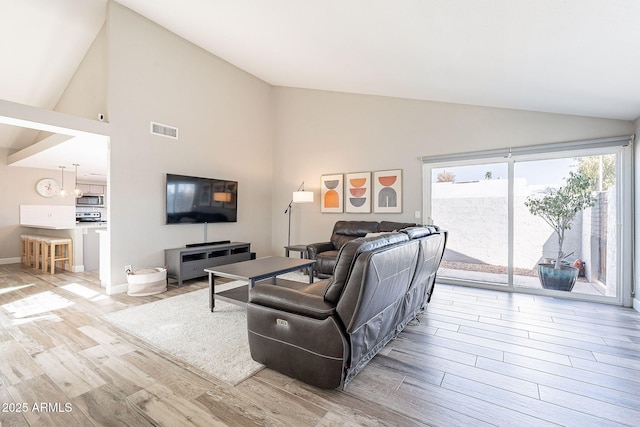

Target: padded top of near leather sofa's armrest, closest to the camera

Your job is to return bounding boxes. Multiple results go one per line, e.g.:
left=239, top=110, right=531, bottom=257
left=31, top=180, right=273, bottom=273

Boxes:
left=249, top=283, right=336, bottom=319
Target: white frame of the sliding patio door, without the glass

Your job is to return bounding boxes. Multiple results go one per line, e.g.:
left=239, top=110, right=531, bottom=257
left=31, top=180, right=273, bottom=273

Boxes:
left=422, top=136, right=635, bottom=307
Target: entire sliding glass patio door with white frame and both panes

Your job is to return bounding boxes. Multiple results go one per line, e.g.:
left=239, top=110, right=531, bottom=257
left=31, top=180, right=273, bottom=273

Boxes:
left=423, top=140, right=633, bottom=303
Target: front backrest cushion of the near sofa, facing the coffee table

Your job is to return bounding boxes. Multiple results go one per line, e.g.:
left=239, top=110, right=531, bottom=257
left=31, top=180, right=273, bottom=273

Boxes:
left=324, top=233, right=409, bottom=304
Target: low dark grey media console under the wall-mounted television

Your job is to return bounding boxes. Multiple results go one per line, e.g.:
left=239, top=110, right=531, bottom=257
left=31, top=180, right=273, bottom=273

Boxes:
left=164, top=242, right=251, bottom=286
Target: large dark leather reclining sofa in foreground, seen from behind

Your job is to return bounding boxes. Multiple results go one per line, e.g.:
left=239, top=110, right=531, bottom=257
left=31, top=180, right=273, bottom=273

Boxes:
left=247, top=227, right=447, bottom=388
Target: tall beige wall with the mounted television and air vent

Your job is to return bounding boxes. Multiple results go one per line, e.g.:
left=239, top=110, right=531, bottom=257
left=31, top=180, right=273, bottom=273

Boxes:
left=107, top=2, right=273, bottom=285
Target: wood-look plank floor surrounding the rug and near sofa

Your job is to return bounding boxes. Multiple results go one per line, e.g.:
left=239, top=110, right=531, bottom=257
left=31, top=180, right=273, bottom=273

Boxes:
left=0, top=264, right=640, bottom=427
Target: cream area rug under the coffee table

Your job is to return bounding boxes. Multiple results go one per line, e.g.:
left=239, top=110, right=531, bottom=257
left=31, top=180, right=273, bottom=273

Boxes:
left=104, top=282, right=263, bottom=385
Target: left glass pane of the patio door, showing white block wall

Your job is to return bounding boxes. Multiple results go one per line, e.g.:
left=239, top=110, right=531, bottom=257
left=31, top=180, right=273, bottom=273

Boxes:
left=430, top=162, right=509, bottom=285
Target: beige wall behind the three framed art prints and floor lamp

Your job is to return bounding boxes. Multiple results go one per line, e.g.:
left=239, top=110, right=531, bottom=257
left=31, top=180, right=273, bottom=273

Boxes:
left=272, top=87, right=634, bottom=258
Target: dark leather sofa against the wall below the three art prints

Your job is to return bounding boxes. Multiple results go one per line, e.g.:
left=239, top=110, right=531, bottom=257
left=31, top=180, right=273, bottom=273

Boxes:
left=307, top=221, right=416, bottom=278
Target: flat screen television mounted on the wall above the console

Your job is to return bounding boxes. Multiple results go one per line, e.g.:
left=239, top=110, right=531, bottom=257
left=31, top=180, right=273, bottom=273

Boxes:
left=166, top=173, right=238, bottom=224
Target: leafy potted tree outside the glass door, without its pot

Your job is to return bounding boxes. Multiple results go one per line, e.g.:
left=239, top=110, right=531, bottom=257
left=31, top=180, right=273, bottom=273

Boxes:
left=524, top=172, right=596, bottom=268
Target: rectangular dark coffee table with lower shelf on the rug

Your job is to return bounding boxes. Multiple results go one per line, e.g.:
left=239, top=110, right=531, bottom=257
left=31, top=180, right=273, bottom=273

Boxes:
left=204, top=256, right=316, bottom=311
